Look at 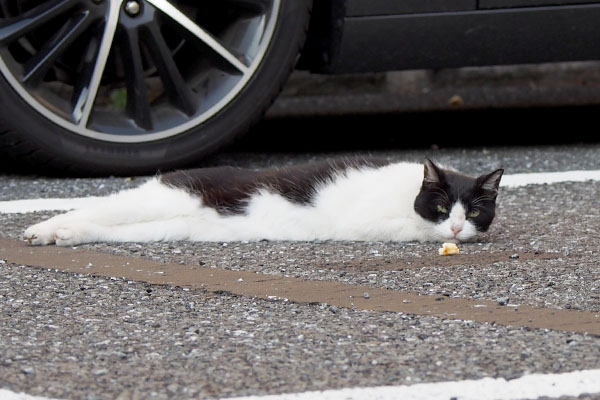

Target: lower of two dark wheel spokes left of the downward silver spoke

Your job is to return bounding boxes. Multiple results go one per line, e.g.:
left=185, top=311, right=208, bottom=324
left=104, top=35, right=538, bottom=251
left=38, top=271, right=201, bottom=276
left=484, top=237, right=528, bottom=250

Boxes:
left=21, top=11, right=91, bottom=86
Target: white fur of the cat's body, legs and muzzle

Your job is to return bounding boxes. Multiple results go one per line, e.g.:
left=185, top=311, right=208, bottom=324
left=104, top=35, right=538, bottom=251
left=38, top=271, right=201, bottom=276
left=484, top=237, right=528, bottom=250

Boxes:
left=25, top=163, right=476, bottom=246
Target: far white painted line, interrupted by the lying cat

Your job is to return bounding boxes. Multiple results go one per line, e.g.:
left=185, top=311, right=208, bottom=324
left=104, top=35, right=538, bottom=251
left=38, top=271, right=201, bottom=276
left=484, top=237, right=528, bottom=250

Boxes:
left=0, top=170, right=600, bottom=214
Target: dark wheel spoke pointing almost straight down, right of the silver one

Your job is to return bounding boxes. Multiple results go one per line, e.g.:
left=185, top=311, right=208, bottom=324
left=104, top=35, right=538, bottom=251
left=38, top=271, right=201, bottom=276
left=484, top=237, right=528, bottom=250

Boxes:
left=121, top=29, right=152, bottom=130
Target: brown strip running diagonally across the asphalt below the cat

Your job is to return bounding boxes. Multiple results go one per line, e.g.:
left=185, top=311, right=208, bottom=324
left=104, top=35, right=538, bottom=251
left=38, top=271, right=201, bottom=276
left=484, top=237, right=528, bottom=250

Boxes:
left=0, top=238, right=600, bottom=335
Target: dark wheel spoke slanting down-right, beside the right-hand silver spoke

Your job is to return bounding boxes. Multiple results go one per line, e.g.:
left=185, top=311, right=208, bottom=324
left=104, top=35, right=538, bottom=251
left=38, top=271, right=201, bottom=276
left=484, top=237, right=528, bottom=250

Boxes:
left=143, top=25, right=197, bottom=115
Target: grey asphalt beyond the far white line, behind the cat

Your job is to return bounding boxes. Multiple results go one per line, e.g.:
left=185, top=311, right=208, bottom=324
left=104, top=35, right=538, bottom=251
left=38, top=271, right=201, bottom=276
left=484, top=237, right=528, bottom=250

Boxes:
left=0, top=144, right=600, bottom=201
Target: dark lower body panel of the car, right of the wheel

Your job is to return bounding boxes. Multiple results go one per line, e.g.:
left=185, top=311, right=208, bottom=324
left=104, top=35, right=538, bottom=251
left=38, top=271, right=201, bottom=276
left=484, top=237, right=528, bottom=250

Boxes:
left=300, top=0, right=600, bottom=73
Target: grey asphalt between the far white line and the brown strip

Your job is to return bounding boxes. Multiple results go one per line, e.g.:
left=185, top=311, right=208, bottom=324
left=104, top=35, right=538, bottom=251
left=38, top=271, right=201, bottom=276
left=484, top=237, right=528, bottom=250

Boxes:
left=0, top=178, right=600, bottom=311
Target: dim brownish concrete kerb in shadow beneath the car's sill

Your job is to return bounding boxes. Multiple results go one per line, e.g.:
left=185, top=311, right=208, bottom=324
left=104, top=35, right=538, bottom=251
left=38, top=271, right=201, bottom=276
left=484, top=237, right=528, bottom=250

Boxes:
left=266, top=61, right=600, bottom=118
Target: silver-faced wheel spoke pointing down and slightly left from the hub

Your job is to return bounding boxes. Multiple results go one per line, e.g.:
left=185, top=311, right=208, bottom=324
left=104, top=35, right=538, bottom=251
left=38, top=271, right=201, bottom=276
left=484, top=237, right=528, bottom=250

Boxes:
left=73, top=0, right=123, bottom=127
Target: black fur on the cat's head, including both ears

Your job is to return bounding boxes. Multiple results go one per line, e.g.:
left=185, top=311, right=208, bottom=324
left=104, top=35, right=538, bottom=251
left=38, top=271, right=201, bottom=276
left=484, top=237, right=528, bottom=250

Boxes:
left=414, top=160, right=504, bottom=232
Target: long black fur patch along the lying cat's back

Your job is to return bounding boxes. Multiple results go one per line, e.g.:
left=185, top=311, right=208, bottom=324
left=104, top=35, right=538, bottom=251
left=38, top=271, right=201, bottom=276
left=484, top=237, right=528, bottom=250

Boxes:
left=161, top=158, right=390, bottom=215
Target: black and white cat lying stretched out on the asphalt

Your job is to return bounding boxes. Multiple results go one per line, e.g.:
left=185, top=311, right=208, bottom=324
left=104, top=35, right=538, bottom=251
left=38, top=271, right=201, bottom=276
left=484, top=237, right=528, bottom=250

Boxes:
left=24, top=158, right=504, bottom=246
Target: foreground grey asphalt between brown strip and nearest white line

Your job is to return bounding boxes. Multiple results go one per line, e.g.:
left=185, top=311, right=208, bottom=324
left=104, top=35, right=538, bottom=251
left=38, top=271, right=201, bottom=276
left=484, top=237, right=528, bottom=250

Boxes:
left=0, top=265, right=600, bottom=399
